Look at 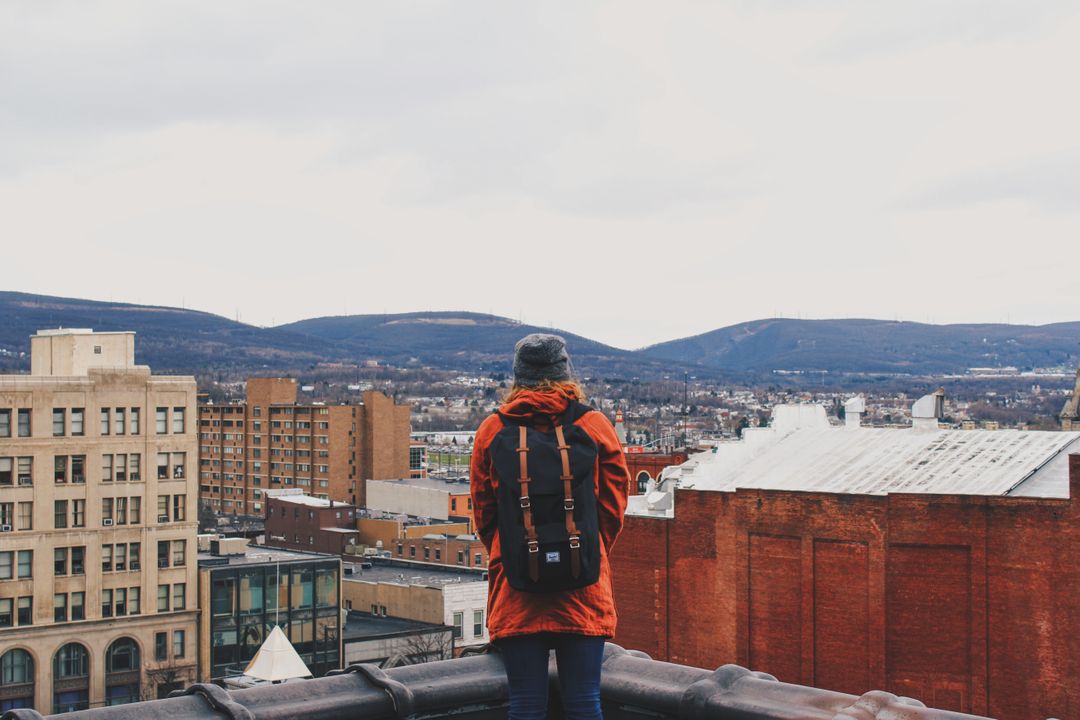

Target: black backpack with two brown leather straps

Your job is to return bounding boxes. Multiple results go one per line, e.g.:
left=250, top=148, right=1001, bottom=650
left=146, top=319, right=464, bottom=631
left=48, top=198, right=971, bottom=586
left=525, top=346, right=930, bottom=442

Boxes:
left=489, top=400, right=600, bottom=593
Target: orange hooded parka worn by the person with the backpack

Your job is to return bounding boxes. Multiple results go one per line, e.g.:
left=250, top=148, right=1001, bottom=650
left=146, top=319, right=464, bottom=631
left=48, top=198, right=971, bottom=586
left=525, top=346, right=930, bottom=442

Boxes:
left=471, top=389, right=630, bottom=640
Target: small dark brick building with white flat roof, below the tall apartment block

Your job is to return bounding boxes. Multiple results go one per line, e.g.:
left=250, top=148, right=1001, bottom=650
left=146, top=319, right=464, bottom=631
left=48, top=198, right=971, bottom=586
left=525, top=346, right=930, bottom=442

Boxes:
left=266, top=490, right=360, bottom=555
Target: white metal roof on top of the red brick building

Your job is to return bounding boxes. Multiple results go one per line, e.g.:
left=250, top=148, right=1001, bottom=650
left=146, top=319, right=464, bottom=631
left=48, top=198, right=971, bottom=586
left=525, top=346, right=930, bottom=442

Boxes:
left=664, top=406, right=1080, bottom=498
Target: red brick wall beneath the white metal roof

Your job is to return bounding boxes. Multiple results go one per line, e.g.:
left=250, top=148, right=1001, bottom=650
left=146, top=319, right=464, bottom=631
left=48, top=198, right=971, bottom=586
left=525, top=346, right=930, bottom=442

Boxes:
left=612, top=456, right=1080, bottom=720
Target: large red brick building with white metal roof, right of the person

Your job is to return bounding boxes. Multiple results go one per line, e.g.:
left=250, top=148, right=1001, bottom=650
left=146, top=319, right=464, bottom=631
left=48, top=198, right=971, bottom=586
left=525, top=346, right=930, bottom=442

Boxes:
left=612, top=399, right=1080, bottom=720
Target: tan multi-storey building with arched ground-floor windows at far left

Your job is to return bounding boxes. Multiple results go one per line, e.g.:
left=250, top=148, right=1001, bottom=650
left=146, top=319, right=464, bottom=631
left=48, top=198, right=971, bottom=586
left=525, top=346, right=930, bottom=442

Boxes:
left=0, top=330, right=198, bottom=715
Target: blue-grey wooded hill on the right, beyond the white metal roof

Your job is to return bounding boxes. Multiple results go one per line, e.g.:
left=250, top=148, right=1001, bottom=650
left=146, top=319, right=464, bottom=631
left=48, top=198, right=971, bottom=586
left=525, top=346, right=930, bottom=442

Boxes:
left=640, top=320, right=1080, bottom=375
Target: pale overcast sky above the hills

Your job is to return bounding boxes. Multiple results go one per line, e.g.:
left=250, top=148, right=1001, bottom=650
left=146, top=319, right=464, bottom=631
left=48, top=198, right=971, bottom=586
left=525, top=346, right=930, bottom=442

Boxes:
left=0, top=0, right=1080, bottom=348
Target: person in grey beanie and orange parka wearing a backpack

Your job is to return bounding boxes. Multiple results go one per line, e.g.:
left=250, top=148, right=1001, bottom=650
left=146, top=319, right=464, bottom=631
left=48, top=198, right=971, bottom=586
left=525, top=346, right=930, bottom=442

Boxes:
left=470, top=334, right=630, bottom=720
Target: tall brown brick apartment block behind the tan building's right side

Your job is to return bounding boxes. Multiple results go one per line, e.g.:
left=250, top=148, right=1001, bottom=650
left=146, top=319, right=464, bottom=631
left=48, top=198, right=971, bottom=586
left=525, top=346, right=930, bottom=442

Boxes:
left=199, top=378, right=410, bottom=517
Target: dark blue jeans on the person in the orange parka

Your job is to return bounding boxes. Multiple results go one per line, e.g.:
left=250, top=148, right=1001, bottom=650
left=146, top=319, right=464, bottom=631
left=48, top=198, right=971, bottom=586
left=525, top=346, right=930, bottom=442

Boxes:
left=496, top=633, right=604, bottom=720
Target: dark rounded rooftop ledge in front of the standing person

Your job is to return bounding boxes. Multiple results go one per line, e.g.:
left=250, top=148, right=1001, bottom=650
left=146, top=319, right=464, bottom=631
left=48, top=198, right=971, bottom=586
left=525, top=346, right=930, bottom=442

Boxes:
left=0, top=643, right=1002, bottom=720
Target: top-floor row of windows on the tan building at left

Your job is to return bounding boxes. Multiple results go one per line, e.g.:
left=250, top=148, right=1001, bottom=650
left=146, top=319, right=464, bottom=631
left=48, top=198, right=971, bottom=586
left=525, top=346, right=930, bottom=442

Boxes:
left=0, top=407, right=187, bottom=437
